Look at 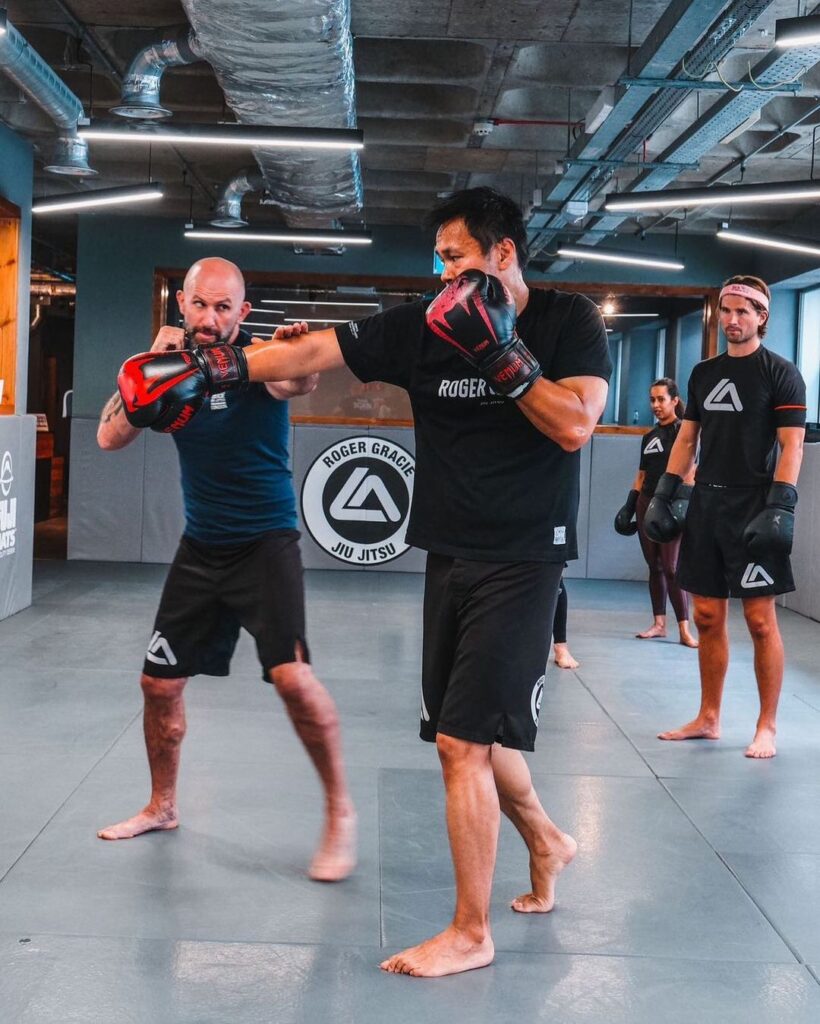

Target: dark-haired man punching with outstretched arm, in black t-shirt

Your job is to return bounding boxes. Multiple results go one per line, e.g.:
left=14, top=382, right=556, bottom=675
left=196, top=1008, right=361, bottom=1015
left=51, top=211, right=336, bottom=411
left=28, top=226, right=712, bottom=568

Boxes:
left=127, top=188, right=611, bottom=977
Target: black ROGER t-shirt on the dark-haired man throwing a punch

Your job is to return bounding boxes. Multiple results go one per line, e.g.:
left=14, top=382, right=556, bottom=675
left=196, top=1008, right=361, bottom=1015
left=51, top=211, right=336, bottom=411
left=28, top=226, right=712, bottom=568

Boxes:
left=336, top=289, right=612, bottom=562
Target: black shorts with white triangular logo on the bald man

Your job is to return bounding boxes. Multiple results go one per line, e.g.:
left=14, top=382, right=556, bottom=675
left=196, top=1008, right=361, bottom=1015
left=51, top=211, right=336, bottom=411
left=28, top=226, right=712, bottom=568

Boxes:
left=142, top=529, right=309, bottom=682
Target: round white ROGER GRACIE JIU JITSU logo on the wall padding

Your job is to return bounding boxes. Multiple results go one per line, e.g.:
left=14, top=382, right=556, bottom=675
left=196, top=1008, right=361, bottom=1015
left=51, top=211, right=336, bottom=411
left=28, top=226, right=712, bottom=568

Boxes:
left=302, top=436, right=416, bottom=565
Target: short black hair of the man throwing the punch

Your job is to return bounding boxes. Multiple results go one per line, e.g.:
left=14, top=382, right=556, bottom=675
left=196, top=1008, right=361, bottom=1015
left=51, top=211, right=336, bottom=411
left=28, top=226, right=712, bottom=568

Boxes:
left=426, top=185, right=529, bottom=270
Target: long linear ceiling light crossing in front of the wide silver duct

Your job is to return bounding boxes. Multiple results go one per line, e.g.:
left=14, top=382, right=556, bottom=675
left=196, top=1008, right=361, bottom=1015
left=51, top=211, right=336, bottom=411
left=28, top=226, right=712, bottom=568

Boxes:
left=77, top=121, right=364, bottom=150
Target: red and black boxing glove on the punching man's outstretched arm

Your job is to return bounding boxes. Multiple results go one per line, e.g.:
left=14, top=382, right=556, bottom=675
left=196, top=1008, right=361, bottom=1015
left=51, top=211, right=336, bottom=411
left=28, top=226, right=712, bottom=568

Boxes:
left=117, top=345, right=248, bottom=433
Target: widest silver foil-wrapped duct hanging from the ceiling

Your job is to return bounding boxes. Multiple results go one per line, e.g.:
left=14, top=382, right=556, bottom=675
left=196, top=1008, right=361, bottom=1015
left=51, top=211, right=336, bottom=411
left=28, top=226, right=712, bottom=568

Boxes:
left=182, top=0, right=362, bottom=227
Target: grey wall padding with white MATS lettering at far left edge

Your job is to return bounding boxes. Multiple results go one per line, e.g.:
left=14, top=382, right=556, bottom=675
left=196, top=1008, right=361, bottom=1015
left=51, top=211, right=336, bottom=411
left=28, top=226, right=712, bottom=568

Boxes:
left=0, top=416, right=37, bottom=618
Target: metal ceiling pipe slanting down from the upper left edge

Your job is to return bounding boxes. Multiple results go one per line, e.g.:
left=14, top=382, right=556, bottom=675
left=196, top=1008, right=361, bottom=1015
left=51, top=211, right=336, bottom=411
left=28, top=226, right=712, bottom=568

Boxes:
left=0, top=14, right=96, bottom=177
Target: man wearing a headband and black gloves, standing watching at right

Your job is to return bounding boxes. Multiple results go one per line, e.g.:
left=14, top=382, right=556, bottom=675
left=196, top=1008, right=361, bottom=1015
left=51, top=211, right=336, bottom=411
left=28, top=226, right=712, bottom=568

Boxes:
left=644, top=276, right=806, bottom=758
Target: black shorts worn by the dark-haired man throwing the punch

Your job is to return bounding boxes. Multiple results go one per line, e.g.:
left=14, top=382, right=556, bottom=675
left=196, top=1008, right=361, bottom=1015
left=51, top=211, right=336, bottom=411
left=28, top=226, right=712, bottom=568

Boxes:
left=420, top=554, right=564, bottom=751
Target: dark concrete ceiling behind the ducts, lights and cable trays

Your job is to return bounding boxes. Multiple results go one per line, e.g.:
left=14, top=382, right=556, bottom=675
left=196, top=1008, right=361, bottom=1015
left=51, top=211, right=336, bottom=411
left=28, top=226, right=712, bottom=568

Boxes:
left=0, top=0, right=820, bottom=272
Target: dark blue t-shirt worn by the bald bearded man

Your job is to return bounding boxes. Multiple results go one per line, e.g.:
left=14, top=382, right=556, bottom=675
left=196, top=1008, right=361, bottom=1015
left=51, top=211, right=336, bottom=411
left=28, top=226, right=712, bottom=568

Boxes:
left=171, top=331, right=297, bottom=544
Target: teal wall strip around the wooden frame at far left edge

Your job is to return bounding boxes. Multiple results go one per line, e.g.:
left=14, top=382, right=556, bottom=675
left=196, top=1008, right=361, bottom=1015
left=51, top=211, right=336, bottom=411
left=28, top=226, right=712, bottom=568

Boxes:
left=0, top=119, right=34, bottom=414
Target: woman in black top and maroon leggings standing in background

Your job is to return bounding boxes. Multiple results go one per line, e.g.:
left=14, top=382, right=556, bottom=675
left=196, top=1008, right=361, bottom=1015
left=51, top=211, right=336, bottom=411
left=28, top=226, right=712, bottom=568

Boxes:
left=615, top=377, right=697, bottom=647
